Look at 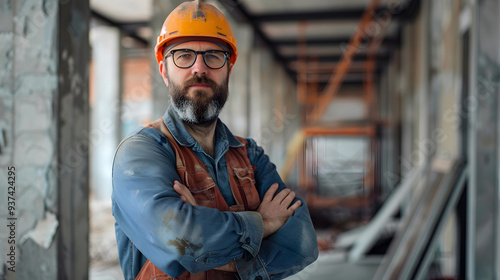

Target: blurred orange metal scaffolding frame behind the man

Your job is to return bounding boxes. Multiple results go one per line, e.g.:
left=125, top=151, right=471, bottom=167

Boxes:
left=281, top=0, right=387, bottom=211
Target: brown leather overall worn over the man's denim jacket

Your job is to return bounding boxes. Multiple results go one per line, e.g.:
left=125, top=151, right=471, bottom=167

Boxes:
left=135, top=118, right=260, bottom=280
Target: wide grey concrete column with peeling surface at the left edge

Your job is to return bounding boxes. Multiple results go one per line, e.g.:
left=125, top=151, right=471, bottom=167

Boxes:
left=0, top=0, right=89, bottom=279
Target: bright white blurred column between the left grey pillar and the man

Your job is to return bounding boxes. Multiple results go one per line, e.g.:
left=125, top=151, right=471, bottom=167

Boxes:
left=89, top=26, right=122, bottom=201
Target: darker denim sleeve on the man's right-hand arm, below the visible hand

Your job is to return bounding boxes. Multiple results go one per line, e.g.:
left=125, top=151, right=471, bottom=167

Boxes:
left=236, top=139, right=319, bottom=279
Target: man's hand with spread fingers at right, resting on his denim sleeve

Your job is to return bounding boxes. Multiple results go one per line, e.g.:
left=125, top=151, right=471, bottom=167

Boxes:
left=257, top=184, right=302, bottom=238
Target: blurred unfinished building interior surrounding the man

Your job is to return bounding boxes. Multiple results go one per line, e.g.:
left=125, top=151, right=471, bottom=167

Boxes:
left=0, top=0, right=500, bottom=280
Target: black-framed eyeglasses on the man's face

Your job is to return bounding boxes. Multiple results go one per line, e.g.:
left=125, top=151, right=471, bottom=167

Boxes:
left=166, top=49, right=229, bottom=69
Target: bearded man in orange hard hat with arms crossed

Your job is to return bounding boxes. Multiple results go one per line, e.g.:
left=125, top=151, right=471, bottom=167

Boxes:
left=112, top=1, right=318, bottom=280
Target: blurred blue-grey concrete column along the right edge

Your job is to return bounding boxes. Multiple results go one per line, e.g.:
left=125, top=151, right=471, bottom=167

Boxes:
left=463, top=0, right=500, bottom=279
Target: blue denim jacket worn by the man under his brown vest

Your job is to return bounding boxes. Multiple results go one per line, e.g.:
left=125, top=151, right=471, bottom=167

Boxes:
left=112, top=108, right=318, bottom=279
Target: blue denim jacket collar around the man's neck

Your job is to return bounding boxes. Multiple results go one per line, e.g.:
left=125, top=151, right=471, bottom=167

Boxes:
left=163, top=105, right=243, bottom=151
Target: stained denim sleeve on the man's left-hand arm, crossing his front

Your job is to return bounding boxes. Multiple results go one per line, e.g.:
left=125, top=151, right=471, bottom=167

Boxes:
left=112, top=128, right=263, bottom=279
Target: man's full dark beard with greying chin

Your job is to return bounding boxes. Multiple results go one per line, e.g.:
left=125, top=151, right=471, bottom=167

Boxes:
left=168, top=75, right=229, bottom=127
